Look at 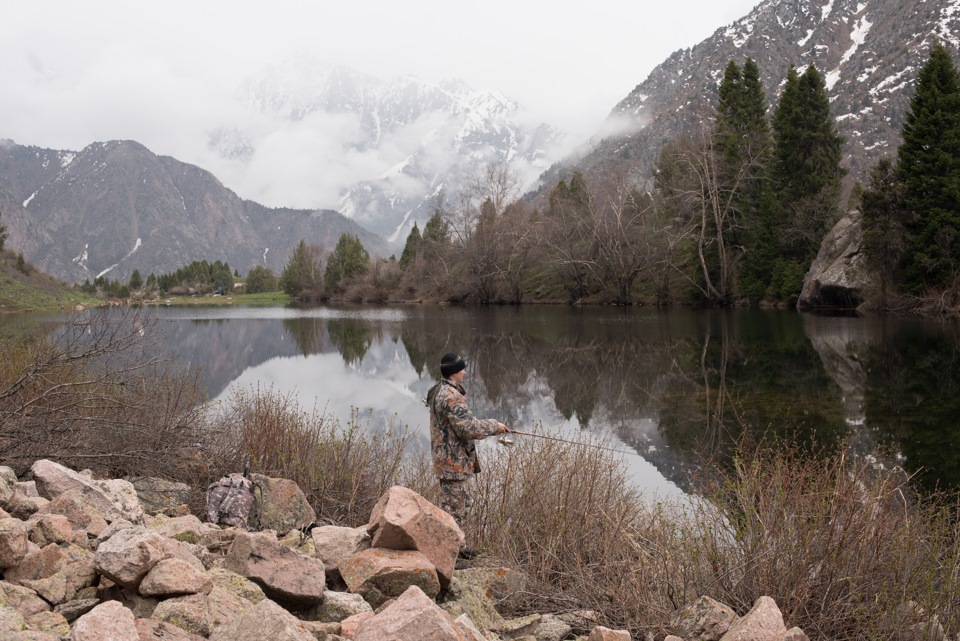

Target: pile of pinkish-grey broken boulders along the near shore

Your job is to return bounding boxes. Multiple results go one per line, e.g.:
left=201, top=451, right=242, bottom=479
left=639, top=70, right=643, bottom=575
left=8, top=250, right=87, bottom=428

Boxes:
left=0, top=460, right=806, bottom=641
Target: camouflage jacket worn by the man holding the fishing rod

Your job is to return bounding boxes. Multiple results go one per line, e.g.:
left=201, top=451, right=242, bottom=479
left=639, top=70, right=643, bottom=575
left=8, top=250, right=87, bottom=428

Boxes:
left=427, top=379, right=500, bottom=481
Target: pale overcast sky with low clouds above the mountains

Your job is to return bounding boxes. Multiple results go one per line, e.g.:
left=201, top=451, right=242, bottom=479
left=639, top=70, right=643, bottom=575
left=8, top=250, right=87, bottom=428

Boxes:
left=0, top=0, right=759, bottom=207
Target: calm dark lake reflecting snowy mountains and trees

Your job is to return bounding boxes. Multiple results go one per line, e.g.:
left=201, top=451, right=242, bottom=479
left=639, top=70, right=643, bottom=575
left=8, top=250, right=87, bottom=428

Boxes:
left=5, top=305, right=960, bottom=497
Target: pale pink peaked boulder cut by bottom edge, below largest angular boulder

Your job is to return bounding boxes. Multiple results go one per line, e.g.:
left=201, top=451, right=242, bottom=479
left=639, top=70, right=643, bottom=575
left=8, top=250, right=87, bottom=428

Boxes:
left=354, top=586, right=463, bottom=641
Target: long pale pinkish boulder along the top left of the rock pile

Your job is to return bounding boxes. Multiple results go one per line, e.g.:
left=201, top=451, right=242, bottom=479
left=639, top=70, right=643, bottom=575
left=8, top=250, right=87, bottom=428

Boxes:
left=30, top=459, right=143, bottom=523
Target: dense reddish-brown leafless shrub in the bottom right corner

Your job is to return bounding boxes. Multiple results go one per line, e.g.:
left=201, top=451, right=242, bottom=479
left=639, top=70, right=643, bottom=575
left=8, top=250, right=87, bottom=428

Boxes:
left=683, top=445, right=960, bottom=639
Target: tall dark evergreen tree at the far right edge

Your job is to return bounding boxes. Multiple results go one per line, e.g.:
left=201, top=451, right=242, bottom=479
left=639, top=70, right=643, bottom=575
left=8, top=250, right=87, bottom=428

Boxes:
left=897, top=42, right=960, bottom=293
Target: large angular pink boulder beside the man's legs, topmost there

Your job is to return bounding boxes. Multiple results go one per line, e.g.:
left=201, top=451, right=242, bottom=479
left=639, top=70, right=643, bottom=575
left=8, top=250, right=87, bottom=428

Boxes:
left=367, top=486, right=464, bottom=588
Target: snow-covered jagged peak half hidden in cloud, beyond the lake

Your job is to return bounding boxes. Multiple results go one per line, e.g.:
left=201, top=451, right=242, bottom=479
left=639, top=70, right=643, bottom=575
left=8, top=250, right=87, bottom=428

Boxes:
left=232, top=55, right=564, bottom=243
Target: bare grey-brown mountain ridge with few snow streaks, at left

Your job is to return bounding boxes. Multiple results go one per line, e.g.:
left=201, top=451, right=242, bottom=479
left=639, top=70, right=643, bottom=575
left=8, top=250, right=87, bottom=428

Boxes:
left=0, top=141, right=389, bottom=282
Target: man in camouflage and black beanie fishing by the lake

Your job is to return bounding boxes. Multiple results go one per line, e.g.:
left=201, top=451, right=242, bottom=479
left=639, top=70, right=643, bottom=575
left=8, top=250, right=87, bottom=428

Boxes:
left=426, top=353, right=510, bottom=536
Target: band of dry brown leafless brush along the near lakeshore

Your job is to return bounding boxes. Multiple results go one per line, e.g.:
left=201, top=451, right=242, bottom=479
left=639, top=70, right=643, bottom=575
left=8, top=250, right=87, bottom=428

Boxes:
left=0, top=309, right=960, bottom=639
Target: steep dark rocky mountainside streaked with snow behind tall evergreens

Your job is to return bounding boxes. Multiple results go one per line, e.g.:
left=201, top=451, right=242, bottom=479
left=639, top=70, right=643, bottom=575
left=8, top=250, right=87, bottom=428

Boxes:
left=564, top=0, right=960, bottom=190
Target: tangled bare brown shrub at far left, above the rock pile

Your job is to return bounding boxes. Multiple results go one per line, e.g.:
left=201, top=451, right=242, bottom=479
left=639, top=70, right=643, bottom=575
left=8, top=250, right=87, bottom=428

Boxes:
left=0, top=309, right=203, bottom=476
